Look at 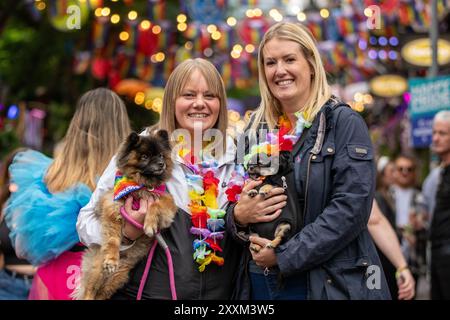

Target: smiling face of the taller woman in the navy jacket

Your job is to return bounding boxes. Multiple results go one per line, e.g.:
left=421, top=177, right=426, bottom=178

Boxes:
left=263, top=38, right=312, bottom=111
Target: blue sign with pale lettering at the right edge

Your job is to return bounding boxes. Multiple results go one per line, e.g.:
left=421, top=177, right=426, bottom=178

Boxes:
left=408, top=76, right=450, bottom=148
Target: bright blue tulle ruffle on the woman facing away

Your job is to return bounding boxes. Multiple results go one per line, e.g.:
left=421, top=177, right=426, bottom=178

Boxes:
left=5, top=150, right=92, bottom=265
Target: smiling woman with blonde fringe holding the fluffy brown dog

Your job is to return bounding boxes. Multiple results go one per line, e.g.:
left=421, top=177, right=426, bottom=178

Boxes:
left=77, top=59, right=240, bottom=300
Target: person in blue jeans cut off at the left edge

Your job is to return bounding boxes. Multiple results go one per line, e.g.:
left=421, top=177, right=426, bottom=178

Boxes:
left=0, top=149, right=36, bottom=300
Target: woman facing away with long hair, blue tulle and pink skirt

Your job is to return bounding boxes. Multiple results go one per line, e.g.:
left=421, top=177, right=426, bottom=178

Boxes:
left=5, top=88, right=130, bottom=300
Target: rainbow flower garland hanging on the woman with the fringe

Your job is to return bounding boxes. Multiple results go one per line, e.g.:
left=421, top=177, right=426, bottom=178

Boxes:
left=179, top=148, right=225, bottom=272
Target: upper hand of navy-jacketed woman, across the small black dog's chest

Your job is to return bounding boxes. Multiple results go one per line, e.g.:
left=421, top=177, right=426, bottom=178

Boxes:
left=234, top=180, right=287, bottom=226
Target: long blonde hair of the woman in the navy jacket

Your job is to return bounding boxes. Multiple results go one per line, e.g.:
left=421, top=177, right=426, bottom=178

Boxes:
left=252, top=22, right=331, bottom=129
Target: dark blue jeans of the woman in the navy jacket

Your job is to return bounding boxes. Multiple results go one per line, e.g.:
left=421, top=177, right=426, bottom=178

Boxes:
left=250, top=272, right=306, bottom=300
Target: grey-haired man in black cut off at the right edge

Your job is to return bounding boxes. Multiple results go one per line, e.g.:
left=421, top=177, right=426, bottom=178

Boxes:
left=430, top=111, right=450, bottom=300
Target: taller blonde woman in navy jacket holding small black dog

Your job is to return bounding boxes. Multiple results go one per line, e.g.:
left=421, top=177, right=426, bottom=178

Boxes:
left=228, top=22, right=390, bottom=299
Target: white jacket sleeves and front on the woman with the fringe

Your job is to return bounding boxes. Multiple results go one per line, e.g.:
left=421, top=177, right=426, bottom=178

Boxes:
left=77, top=131, right=236, bottom=246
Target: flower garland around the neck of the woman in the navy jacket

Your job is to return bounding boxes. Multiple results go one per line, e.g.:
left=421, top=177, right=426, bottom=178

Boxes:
left=225, top=111, right=312, bottom=202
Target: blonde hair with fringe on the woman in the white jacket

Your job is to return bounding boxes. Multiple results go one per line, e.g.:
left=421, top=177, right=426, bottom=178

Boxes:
left=151, top=58, right=228, bottom=147
